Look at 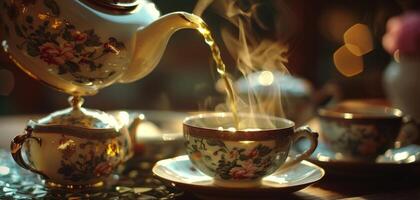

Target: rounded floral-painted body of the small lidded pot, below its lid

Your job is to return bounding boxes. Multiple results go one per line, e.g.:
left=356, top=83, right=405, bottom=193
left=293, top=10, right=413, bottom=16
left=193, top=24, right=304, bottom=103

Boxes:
left=20, top=128, right=127, bottom=186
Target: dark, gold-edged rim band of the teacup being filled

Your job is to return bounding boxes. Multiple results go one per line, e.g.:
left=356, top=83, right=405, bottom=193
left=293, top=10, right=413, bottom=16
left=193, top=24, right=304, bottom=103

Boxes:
left=183, top=112, right=295, bottom=141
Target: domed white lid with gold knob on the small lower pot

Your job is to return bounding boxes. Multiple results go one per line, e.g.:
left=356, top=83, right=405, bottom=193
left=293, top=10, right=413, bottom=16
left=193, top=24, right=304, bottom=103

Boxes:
left=35, top=97, right=120, bottom=129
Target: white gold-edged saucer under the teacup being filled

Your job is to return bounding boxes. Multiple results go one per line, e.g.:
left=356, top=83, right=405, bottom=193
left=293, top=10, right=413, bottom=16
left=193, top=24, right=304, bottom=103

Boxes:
left=152, top=155, right=325, bottom=199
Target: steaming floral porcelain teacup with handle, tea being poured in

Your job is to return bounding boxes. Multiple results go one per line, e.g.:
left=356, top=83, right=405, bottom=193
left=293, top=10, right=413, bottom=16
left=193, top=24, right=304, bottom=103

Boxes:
left=183, top=113, right=318, bottom=187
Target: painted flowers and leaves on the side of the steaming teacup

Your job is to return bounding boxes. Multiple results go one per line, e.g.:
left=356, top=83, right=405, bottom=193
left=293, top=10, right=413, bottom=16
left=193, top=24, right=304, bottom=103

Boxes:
left=185, top=137, right=276, bottom=180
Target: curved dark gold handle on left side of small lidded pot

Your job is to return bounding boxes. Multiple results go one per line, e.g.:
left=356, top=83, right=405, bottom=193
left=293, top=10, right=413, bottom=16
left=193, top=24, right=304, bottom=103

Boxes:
left=10, top=126, right=47, bottom=179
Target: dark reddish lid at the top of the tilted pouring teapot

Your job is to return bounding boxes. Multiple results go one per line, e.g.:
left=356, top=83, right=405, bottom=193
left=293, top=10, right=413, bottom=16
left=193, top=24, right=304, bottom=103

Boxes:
left=83, top=0, right=141, bottom=11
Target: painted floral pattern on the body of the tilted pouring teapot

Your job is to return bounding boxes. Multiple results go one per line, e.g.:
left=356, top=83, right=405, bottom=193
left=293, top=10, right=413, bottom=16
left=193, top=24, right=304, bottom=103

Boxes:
left=2, top=0, right=126, bottom=84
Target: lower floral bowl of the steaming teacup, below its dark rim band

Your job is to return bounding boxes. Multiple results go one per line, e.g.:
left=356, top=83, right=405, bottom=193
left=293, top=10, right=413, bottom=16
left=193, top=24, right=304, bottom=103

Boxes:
left=185, top=136, right=289, bottom=180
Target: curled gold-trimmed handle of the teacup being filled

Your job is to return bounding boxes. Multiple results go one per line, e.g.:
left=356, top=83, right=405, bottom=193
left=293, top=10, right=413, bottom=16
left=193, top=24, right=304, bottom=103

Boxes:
left=277, top=126, right=318, bottom=171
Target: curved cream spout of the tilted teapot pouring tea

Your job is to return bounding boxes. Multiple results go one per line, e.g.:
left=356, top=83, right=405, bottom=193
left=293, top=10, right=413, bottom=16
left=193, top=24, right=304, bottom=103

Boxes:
left=119, top=12, right=204, bottom=83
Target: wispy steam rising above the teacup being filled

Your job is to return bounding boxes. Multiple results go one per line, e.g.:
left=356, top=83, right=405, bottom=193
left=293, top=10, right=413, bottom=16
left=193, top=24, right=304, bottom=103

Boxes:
left=194, top=0, right=289, bottom=123
